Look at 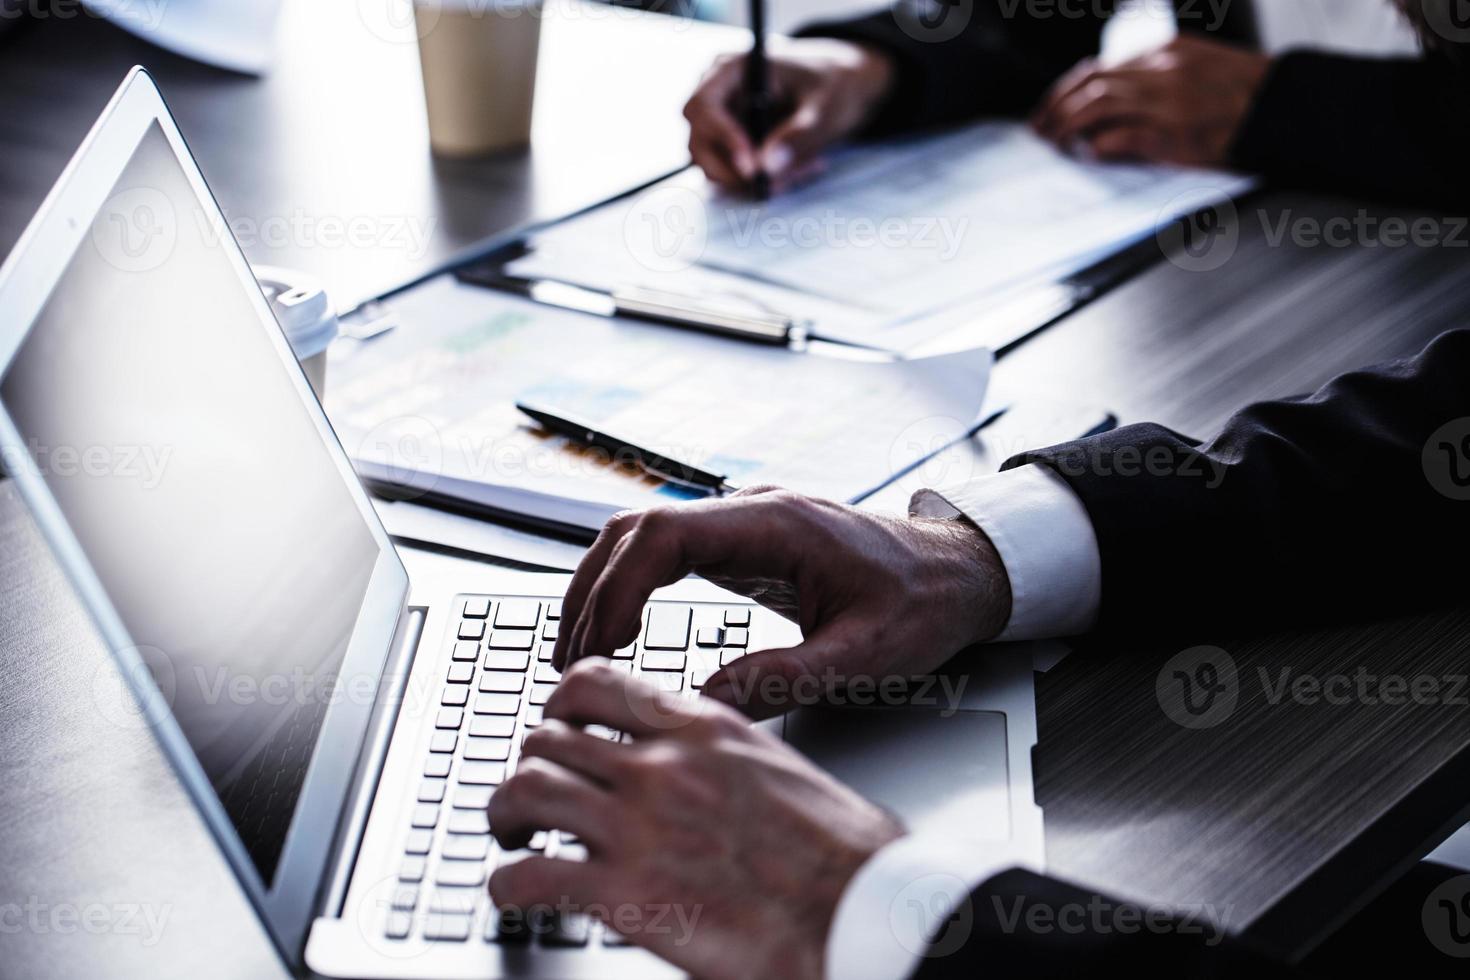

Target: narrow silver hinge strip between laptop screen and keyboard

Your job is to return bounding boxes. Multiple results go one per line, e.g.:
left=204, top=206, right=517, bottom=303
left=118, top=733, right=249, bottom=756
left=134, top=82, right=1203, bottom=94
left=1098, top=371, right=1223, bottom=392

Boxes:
left=320, top=607, right=428, bottom=917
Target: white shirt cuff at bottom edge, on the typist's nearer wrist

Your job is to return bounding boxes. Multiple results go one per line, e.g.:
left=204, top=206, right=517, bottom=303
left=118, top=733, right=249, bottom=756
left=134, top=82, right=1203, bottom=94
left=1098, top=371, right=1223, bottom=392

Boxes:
left=826, top=836, right=1041, bottom=980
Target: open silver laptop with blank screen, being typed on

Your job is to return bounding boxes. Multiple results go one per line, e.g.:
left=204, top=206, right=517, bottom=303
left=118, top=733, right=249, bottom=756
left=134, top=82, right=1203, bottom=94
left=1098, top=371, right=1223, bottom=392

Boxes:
left=0, top=69, right=1042, bottom=977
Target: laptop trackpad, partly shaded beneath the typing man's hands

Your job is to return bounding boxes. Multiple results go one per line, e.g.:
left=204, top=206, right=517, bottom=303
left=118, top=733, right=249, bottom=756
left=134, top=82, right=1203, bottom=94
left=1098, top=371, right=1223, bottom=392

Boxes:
left=782, top=708, right=1011, bottom=840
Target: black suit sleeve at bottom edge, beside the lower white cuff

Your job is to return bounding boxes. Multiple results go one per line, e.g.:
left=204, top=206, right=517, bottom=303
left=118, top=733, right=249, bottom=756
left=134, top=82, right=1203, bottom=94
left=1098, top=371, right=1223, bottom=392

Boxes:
left=914, top=871, right=1291, bottom=980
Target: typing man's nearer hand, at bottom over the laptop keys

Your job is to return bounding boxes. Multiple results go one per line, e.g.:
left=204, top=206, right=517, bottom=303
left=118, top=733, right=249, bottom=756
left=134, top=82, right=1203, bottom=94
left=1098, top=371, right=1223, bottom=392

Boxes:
left=490, top=663, right=903, bottom=979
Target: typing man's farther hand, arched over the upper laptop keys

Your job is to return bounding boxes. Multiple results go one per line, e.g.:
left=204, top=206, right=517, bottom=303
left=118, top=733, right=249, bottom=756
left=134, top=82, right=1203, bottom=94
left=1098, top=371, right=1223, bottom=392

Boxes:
left=553, top=488, right=1011, bottom=716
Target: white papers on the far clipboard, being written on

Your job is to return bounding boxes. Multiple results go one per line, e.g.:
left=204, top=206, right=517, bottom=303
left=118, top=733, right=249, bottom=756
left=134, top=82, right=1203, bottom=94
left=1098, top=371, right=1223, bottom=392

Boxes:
left=506, top=122, right=1254, bottom=351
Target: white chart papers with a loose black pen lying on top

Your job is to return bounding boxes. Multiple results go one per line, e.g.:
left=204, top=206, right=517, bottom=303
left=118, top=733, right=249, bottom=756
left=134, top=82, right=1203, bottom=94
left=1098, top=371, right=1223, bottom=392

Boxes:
left=325, top=275, right=991, bottom=529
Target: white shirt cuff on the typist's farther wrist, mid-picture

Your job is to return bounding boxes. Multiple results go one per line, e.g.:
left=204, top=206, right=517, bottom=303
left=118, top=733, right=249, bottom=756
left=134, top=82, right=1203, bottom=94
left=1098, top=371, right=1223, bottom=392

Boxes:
left=908, top=463, right=1103, bottom=641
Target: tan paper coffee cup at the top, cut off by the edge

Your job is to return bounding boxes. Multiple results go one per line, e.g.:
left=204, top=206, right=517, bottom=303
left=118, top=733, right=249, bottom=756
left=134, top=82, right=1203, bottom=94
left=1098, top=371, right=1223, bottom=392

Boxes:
left=413, top=0, right=542, bottom=157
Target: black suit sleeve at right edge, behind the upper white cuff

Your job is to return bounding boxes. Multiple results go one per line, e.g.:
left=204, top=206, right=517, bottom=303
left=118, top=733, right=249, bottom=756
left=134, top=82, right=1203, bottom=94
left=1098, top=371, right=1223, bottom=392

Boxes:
left=1007, top=329, right=1470, bottom=633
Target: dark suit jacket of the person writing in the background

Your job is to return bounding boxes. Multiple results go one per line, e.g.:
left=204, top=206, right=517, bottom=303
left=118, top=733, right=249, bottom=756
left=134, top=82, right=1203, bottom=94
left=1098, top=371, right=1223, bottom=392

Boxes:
left=801, top=0, right=1470, bottom=207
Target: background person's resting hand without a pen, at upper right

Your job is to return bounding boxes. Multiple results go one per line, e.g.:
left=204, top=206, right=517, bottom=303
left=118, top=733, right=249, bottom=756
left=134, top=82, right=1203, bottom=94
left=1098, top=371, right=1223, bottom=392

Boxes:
left=1032, top=37, right=1272, bottom=166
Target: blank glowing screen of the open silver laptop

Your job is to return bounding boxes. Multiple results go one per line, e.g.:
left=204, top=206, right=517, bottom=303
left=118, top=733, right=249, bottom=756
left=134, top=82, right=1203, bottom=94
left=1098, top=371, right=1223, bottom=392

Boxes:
left=0, top=123, right=378, bottom=887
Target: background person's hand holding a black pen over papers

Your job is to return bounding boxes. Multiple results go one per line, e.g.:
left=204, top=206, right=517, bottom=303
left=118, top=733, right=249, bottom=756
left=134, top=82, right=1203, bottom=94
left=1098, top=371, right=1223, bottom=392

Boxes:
left=684, top=38, right=894, bottom=191
